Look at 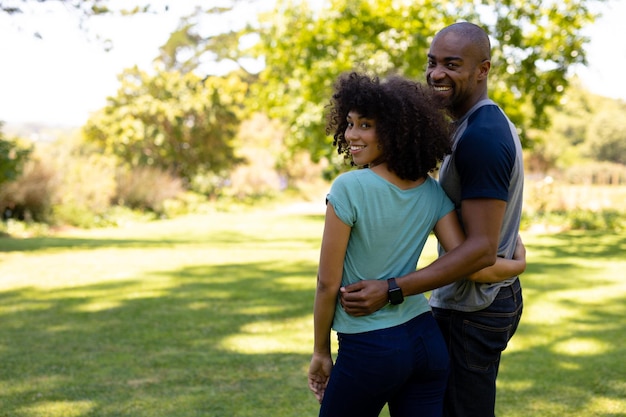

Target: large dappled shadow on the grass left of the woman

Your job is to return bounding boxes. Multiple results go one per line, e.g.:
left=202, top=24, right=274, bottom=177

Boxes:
left=0, top=261, right=317, bottom=417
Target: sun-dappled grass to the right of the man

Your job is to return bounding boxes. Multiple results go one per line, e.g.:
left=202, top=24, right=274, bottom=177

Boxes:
left=498, top=232, right=626, bottom=417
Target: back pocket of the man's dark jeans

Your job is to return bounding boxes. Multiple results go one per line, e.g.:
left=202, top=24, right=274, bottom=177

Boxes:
left=463, top=320, right=512, bottom=371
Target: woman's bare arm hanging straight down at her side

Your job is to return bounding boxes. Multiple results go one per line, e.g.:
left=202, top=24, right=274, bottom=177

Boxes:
left=309, top=203, right=351, bottom=403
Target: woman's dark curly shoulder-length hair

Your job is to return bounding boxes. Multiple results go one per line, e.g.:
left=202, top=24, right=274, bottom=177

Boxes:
left=326, top=72, right=451, bottom=181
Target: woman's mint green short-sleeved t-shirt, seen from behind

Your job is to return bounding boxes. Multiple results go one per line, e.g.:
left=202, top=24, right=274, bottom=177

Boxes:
left=327, top=169, right=454, bottom=333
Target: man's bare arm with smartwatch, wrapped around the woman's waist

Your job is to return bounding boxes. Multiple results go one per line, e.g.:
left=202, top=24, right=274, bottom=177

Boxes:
left=340, top=198, right=506, bottom=316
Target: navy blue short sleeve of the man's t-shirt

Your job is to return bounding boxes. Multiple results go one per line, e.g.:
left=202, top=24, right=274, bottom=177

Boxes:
left=456, top=106, right=516, bottom=201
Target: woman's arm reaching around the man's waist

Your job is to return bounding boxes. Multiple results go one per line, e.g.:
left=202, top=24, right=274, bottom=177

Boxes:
left=434, top=213, right=526, bottom=283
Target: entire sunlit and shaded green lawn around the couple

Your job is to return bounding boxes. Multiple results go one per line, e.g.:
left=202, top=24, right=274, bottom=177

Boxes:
left=0, top=206, right=626, bottom=417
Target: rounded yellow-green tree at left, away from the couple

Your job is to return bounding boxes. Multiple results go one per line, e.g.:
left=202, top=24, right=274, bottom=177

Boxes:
left=84, top=68, right=247, bottom=185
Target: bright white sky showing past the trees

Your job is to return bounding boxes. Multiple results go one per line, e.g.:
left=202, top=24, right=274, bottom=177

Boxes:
left=0, top=0, right=626, bottom=126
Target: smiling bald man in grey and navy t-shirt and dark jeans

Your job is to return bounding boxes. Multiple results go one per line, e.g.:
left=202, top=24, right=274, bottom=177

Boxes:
left=341, top=22, right=524, bottom=417
